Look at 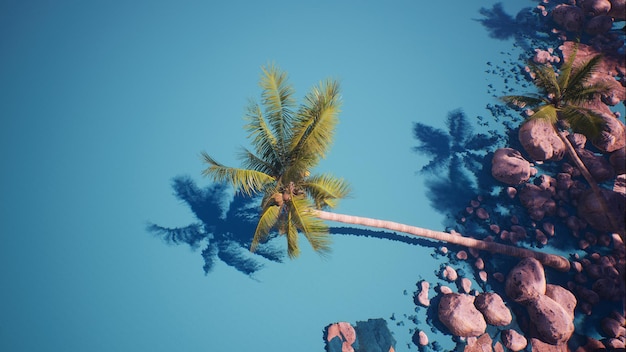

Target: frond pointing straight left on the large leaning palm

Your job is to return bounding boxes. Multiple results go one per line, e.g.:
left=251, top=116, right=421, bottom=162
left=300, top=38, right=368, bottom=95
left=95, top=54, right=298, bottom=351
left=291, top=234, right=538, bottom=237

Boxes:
left=202, top=152, right=275, bottom=195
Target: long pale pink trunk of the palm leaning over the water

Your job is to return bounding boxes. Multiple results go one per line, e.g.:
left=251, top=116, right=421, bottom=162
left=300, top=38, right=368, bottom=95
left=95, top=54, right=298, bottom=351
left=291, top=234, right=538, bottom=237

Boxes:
left=315, top=210, right=570, bottom=271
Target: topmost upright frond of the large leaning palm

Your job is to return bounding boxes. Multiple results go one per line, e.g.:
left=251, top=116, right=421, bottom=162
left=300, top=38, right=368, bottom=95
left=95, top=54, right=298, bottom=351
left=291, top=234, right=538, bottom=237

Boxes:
left=261, top=64, right=295, bottom=154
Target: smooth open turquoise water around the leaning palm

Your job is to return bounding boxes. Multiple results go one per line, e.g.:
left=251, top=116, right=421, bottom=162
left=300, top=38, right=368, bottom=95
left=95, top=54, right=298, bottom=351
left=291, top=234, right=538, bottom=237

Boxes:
left=0, top=0, right=620, bottom=352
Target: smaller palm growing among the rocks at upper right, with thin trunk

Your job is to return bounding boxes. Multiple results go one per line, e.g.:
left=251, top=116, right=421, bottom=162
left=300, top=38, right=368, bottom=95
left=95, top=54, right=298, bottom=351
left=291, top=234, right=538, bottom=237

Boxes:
left=501, top=47, right=623, bottom=232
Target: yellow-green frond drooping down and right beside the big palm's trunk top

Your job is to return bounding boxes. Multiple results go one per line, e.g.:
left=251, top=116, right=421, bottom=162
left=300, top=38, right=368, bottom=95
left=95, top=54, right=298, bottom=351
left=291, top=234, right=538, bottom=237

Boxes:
left=289, top=197, right=330, bottom=255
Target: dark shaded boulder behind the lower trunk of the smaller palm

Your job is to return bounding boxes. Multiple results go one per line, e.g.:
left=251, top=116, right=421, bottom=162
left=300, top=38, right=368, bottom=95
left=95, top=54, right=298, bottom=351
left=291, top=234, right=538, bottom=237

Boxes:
left=578, top=188, right=626, bottom=232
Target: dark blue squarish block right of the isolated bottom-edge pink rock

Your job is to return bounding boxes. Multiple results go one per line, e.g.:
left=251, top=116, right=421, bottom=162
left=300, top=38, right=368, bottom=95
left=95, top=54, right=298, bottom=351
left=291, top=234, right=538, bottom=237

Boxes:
left=354, top=318, right=396, bottom=352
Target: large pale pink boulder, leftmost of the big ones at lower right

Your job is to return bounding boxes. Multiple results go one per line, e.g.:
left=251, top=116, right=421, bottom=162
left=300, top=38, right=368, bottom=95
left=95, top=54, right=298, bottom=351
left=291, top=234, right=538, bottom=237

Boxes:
left=438, top=293, right=487, bottom=337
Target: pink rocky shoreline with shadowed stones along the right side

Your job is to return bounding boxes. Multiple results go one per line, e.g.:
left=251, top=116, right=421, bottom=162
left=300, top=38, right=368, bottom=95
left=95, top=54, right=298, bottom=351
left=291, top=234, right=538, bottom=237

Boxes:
left=325, top=0, right=626, bottom=352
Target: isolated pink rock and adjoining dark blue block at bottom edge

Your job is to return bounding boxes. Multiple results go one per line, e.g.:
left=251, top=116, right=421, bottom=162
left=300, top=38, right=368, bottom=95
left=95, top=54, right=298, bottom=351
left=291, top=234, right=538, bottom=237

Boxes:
left=324, top=318, right=396, bottom=352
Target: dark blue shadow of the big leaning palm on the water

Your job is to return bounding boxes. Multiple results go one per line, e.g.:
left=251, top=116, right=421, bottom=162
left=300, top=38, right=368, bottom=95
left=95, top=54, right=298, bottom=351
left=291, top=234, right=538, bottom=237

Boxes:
left=147, top=176, right=436, bottom=278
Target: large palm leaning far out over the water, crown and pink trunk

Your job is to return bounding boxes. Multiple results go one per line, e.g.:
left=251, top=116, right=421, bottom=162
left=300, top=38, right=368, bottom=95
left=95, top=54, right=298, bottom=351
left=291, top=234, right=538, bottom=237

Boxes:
left=202, top=65, right=569, bottom=270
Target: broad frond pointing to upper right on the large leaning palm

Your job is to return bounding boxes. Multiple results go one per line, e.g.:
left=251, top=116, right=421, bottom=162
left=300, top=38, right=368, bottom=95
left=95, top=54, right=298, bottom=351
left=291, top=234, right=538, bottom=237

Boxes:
left=290, top=80, right=341, bottom=162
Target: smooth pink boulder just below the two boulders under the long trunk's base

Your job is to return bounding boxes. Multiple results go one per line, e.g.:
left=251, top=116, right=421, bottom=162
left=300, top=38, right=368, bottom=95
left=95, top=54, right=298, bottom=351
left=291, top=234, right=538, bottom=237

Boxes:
left=526, top=295, right=574, bottom=345
